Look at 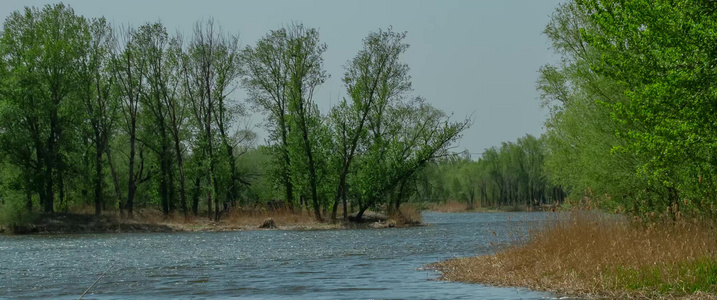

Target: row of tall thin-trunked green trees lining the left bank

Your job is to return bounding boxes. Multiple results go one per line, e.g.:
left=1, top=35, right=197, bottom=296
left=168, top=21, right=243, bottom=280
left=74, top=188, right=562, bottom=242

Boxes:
left=0, top=4, right=470, bottom=220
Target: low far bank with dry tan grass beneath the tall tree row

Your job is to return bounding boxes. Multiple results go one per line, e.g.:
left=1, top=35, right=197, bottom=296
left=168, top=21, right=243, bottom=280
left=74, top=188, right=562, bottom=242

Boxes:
left=0, top=210, right=422, bottom=234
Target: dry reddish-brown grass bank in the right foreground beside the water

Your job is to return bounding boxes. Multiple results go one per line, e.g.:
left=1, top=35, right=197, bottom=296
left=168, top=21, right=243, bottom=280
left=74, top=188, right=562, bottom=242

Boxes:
left=432, top=212, right=717, bottom=299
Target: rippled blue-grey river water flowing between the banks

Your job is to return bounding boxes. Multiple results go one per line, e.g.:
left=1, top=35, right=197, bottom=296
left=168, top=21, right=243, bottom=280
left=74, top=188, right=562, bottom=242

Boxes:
left=0, top=213, right=553, bottom=299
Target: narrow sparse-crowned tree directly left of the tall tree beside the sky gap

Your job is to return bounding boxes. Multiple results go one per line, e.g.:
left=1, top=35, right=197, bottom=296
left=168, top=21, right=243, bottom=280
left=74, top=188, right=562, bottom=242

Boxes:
left=182, top=19, right=242, bottom=220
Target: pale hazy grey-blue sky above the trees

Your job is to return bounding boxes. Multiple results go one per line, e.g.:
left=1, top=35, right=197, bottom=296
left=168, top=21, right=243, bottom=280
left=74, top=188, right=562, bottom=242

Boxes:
left=0, top=0, right=561, bottom=155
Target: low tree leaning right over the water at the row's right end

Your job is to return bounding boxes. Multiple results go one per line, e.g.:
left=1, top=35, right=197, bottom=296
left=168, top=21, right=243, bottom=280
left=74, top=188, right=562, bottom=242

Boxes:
left=352, top=98, right=471, bottom=220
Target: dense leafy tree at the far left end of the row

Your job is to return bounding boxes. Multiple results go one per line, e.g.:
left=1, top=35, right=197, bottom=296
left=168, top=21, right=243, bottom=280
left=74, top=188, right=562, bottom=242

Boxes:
left=0, top=4, right=87, bottom=212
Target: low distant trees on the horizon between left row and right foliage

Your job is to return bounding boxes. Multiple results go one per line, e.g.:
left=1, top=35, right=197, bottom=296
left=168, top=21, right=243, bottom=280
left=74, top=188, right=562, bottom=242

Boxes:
left=414, top=135, right=566, bottom=208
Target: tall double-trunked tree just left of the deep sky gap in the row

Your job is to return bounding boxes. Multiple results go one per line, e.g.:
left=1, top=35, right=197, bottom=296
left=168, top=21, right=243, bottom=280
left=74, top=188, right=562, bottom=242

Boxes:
left=243, top=24, right=328, bottom=220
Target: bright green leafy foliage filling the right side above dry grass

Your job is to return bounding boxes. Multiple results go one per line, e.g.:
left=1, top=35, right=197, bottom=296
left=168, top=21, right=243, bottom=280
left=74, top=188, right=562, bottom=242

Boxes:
left=538, top=0, right=717, bottom=216
